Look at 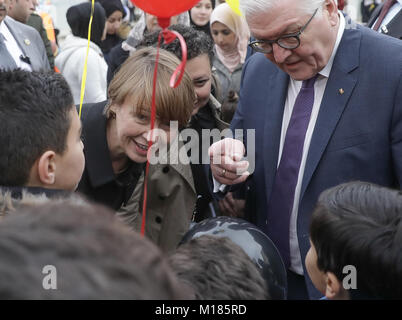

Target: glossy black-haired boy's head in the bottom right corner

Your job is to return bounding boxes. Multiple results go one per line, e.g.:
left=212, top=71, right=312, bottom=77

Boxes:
left=306, top=182, right=402, bottom=299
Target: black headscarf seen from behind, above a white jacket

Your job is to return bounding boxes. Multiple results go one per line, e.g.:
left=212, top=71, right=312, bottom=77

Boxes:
left=66, top=2, right=106, bottom=46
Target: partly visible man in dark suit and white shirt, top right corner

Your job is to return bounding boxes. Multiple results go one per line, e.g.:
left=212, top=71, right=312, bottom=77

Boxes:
left=367, top=0, right=402, bottom=39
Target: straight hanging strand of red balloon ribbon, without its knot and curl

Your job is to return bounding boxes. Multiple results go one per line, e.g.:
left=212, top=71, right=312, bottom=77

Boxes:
left=141, top=31, right=162, bottom=236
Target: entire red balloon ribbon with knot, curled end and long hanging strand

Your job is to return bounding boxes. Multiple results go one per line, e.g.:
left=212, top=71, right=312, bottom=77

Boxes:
left=141, top=25, right=187, bottom=236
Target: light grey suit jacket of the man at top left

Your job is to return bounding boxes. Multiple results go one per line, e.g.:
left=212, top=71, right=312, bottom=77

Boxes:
left=0, top=16, right=50, bottom=71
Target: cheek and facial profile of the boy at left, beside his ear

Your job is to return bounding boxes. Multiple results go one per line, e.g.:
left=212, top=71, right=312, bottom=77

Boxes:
left=53, top=106, right=85, bottom=191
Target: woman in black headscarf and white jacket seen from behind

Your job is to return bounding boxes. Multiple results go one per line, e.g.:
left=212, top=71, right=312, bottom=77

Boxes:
left=55, top=2, right=107, bottom=104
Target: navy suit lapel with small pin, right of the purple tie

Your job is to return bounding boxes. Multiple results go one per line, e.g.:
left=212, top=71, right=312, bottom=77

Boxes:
left=300, top=29, right=361, bottom=199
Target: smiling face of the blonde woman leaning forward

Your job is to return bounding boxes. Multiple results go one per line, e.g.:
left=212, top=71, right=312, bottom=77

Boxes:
left=111, top=97, right=171, bottom=163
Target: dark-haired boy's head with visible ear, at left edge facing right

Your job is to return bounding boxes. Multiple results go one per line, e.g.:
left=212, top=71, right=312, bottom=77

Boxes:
left=0, top=70, right=85, bottom=190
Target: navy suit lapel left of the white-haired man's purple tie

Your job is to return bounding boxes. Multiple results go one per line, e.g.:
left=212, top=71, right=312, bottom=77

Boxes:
left=264, top=69, right=289, bottom=200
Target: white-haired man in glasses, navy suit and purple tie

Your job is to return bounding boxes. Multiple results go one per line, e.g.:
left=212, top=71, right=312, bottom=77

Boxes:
left=209, top=0, right=402, bottom=299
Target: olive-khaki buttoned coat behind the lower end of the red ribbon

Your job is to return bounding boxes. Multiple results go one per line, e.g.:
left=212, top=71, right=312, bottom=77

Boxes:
left=117, top=136, right=196, bottom=252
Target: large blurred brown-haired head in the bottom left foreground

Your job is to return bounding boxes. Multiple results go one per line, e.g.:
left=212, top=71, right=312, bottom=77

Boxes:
left=0, top=199, right=187, bottom=300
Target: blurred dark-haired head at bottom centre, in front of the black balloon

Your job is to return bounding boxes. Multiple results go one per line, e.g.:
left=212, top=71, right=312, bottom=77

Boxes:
left=169, top=235, right=269, bottom=300
